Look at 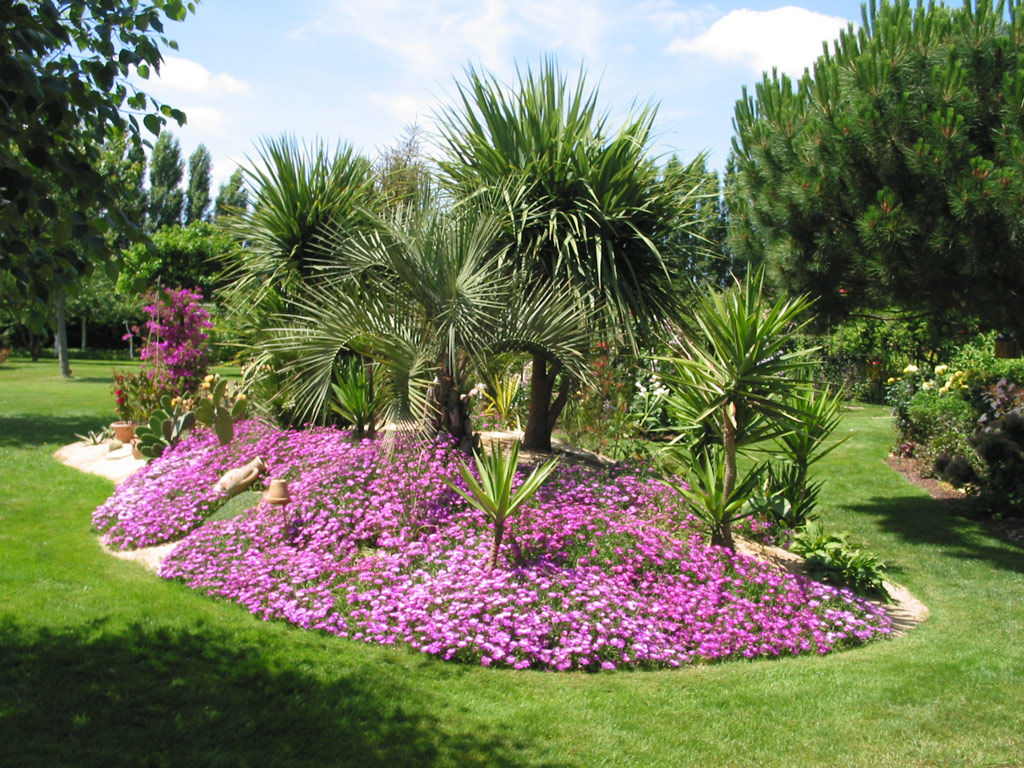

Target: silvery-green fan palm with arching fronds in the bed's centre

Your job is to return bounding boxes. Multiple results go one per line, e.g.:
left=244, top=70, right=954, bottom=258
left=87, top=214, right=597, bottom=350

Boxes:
left=261, top=201, right=592, bottom=451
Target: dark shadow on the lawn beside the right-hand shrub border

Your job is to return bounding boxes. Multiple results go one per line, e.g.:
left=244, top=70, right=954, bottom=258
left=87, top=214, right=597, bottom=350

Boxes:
left=849, top=496, right=1024, bottom=573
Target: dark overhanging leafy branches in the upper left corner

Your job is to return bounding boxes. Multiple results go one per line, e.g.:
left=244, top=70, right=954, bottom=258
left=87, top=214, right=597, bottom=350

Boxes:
left=0, top=0, right=195, bottom=307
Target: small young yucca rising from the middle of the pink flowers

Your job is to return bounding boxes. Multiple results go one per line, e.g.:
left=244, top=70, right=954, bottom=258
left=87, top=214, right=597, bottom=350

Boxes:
left=444, top=441, right=558, bottom=568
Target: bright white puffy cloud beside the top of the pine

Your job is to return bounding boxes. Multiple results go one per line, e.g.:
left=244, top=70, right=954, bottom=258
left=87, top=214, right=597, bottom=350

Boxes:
left=669, top=5, right=848, bottom=76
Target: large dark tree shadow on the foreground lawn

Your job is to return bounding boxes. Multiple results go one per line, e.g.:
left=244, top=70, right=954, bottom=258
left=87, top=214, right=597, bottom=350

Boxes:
left=0, top=615, right=554, bottom=768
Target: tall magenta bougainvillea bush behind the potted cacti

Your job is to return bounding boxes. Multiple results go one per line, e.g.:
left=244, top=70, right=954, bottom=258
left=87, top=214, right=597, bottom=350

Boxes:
left=139, top=288, right=213, bottom=392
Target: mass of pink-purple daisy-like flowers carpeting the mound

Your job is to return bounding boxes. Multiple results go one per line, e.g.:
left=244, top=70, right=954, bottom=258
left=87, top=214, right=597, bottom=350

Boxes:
left=93, top=423, right=891, bottom=670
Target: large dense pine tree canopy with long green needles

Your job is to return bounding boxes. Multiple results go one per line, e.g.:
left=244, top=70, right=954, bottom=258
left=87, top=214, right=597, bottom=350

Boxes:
left=729, top=0, right=1024, bottom=330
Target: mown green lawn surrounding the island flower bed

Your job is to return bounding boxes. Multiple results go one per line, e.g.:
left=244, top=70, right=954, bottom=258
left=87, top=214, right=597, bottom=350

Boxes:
left=0, top=360, right=1024, bottom=768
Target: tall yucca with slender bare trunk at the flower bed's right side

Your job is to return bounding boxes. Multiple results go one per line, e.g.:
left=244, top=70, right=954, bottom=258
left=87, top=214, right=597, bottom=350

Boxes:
left=663, top=273, right=814, bottom=549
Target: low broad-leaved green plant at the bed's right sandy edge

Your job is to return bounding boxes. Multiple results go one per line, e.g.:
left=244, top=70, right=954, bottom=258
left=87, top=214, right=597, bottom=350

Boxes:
left=791, top=527, right=892, bottom=602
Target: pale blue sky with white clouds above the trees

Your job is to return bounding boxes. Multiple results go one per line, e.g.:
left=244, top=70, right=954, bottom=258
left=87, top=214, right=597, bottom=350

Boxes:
left=136, top=0, right=860, bottom=186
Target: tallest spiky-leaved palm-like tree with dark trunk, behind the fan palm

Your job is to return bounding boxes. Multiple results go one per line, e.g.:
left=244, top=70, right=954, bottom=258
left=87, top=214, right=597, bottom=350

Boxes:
left=438, top=60, right=702, bottom=451
